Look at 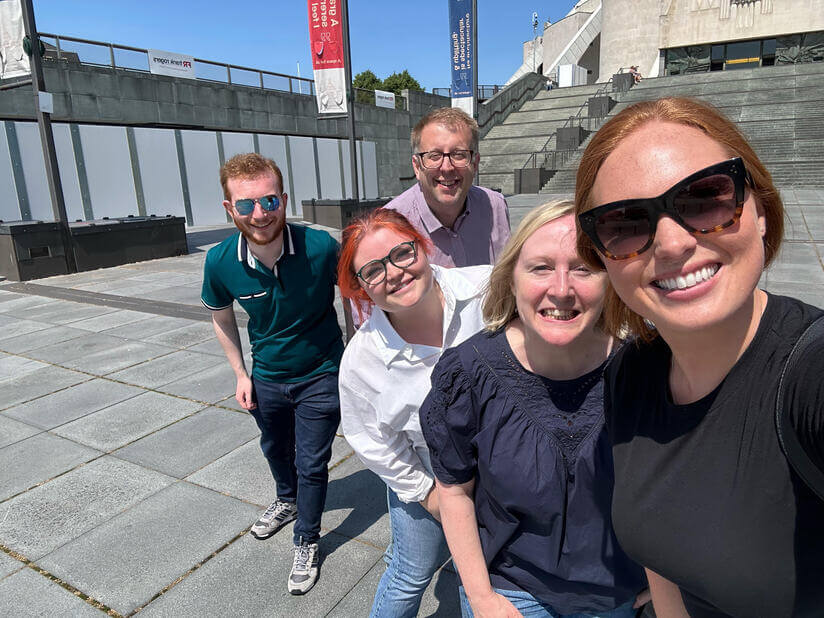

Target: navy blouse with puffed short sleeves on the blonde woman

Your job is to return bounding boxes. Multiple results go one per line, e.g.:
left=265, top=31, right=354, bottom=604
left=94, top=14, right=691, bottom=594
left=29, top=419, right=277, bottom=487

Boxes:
left=420, top=330, right=645, bottom=614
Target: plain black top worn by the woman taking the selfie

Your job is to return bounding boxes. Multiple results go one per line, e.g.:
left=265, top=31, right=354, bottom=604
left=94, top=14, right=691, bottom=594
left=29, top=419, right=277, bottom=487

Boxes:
left=606, top=295, right=824, bottom=618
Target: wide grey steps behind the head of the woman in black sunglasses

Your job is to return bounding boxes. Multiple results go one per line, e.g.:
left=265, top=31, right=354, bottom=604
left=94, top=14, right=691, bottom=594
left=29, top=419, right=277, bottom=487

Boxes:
left=536, top=63, right=824, bottom=194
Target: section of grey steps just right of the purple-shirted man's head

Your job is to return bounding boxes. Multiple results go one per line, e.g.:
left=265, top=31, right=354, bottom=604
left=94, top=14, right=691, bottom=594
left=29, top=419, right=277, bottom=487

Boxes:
left=479, top=84, right=603, bottom=194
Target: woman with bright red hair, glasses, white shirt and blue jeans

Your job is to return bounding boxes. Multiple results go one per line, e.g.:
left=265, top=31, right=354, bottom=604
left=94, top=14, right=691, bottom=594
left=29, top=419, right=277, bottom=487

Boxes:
left=338, top=209, right=491, bottom=618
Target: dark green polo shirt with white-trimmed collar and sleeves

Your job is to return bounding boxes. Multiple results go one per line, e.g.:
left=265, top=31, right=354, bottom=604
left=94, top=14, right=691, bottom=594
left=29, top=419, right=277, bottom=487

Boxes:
left=201, top=225, right=343, bottom=382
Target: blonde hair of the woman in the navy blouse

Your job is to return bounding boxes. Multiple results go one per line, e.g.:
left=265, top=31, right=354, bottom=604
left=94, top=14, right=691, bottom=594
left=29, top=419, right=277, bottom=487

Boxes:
left=483, top=200, right=575, bottom=331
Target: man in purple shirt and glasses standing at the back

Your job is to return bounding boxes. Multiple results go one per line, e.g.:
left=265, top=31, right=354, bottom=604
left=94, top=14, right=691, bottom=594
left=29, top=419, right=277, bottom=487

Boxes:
left=384, top=107, right=509, bottom=268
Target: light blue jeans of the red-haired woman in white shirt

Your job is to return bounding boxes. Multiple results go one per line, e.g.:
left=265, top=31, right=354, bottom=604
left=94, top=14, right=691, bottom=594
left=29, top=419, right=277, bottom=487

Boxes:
left=369, top=488, right=449, bottom=618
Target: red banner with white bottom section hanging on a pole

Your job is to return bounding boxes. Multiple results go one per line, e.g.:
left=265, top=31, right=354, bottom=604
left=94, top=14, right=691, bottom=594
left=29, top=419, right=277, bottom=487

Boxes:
left=308, top=0, right=346, bottom=114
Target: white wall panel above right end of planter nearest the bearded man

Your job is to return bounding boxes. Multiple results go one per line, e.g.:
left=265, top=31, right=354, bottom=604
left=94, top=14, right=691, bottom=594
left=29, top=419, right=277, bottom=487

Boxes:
left=134, top=128, right=186, bottom=217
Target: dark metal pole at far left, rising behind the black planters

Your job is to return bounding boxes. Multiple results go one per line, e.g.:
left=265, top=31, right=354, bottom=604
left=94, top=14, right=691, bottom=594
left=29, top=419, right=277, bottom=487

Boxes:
left=20, top=0, right=77, bottom=273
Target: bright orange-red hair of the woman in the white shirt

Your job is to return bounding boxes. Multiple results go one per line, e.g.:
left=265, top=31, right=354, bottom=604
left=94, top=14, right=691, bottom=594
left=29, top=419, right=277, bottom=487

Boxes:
left=338, top=208, right=432, bottom=318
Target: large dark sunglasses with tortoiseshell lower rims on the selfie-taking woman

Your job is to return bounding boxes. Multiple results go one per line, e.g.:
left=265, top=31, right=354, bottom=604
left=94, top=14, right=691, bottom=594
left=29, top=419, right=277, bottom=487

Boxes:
left=578, top=157, right=749, bottom=260
